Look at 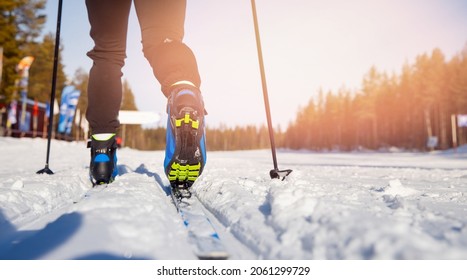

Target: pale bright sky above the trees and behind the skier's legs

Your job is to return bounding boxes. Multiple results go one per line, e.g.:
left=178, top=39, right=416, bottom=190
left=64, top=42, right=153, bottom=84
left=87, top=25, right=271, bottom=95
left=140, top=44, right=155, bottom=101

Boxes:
left=45, top=0, right=467, bottom=128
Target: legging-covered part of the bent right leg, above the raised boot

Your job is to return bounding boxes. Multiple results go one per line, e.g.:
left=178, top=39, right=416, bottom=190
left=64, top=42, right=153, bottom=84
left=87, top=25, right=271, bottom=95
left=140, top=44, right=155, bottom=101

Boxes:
left=135, top=0, right=201, bottom=97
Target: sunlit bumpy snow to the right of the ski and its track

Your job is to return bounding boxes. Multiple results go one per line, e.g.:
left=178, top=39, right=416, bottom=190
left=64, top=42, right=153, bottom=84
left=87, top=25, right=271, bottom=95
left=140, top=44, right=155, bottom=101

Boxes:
left=197, top=148, right=467, bottom=259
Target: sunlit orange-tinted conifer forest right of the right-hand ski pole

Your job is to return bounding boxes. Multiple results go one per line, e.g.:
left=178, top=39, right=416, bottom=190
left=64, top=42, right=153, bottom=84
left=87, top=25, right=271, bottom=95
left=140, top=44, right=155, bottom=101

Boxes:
left=283, top=46, right=467, bottom=150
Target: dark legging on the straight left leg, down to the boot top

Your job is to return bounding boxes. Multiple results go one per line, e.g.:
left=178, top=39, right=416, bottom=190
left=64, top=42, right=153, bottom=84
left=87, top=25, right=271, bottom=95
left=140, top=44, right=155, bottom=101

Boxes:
left=86, top=0, right=131, bottom=134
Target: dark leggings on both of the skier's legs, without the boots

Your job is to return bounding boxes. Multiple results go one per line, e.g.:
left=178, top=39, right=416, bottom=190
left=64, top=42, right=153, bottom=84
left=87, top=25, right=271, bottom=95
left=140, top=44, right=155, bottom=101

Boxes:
left=86, top=0, right=201, bottom=134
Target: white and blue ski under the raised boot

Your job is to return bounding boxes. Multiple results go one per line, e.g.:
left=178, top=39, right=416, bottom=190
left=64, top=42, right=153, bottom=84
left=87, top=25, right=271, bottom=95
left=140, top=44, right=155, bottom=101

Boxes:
left=170, top=187, right=229, bottom=260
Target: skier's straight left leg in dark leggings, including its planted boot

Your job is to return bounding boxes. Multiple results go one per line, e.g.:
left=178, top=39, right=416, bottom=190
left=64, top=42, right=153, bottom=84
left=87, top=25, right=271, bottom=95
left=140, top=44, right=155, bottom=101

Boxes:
left=86, top=0, right=131, bottom=184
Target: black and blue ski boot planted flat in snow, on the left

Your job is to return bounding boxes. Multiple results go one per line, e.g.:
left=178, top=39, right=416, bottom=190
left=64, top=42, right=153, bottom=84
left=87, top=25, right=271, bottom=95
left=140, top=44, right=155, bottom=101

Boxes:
left=88, top=133, right=118, bottom=186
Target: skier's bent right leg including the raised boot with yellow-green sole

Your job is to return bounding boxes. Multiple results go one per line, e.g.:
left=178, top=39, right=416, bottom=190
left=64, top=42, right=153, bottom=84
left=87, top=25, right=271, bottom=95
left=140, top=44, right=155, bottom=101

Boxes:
left=135, top=0, right=206, bottom=187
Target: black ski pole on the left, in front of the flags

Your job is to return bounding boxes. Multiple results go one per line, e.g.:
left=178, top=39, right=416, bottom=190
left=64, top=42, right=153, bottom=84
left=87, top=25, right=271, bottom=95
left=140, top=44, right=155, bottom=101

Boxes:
left=36, top=0, right=63, bottom=174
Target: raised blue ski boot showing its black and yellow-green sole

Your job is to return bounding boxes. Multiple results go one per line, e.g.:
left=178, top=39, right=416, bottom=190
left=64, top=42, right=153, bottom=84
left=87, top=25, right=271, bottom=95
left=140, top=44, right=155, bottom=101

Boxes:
left=164, top=85, right=206, bottom=188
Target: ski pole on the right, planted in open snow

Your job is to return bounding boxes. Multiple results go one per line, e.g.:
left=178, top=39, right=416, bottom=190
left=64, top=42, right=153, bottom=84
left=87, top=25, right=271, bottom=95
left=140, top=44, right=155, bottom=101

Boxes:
left=251, top=0, right=292, bottom=180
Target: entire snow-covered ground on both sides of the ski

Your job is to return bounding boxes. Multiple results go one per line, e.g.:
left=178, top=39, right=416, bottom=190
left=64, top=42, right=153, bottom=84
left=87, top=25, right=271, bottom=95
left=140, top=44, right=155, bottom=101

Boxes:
left=0, top=138, right=467, bottom=259
